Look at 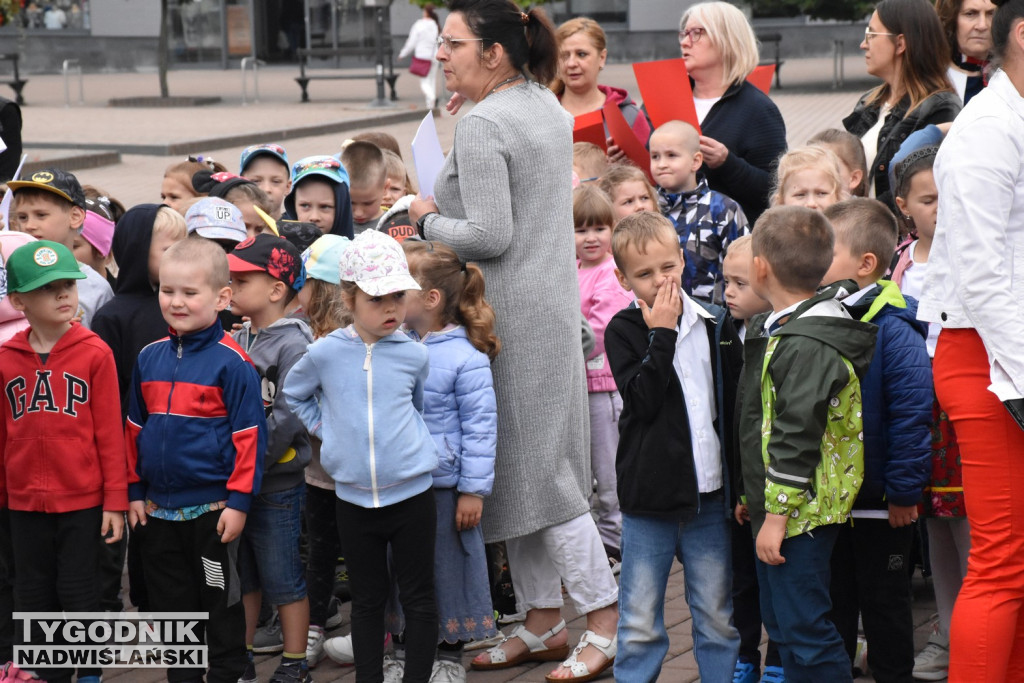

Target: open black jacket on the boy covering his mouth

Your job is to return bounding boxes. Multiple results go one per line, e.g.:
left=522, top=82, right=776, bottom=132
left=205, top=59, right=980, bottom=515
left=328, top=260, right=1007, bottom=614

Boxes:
left=604, top=302, right=742, bottom=521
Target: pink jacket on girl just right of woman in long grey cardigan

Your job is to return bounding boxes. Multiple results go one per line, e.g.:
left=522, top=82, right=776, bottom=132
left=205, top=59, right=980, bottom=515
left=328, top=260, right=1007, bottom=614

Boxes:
left=577, top=258, right=633, bottom=393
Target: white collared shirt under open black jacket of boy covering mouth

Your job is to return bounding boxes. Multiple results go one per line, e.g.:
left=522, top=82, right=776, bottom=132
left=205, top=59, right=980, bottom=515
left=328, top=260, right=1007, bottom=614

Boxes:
left=672, top=291, right=724, bottom=494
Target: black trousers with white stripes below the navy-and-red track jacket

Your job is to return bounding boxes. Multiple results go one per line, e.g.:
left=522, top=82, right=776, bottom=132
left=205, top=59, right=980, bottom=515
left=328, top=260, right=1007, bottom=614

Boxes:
left=135, top=510, right=247, bottom=683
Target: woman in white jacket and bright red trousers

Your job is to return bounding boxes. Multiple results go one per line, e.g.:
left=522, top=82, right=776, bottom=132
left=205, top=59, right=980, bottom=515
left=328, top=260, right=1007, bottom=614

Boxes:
left=918, top=0, right=1024, bottom=683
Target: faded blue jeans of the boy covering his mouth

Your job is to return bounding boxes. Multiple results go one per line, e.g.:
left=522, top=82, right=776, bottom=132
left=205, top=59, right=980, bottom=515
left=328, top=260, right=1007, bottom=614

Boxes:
left=615, top=490, right=739, bottom=683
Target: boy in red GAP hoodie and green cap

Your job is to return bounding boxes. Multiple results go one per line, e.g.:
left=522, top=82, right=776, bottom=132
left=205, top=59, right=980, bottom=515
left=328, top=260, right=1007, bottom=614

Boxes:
left=0, top=240, right=128, bottom=683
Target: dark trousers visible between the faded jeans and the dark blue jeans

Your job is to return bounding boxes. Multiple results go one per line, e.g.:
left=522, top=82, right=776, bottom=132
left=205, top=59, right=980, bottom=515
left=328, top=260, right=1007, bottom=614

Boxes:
left=729, top=519, right=782, bottom=669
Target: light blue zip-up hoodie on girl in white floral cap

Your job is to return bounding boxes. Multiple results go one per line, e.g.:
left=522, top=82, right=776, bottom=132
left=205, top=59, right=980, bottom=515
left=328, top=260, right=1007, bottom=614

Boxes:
left=284, top=326, right=437, bottom=508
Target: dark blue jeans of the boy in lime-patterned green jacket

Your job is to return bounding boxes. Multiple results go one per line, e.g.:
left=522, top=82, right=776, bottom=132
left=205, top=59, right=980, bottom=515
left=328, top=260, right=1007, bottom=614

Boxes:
left=757, top=524, right=853, bottom=683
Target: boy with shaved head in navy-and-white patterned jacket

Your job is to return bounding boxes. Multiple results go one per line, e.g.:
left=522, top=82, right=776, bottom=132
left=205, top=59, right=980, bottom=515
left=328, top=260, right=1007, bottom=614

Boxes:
left=649, top=121, right=749, bottom=305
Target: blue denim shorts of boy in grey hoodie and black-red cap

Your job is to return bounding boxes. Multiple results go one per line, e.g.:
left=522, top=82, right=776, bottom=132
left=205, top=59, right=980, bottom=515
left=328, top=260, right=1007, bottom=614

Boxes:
left=239, top=483, right=306, bottom=605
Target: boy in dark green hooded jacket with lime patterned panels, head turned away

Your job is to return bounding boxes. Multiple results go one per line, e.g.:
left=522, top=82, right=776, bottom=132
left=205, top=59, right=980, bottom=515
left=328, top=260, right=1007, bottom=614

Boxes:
left=738, top=207, right=876, bottom=682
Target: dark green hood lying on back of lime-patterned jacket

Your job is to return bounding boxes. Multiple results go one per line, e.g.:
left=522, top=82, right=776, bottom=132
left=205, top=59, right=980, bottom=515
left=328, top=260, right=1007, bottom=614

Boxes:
left=774, top=281, right=879, bottom=377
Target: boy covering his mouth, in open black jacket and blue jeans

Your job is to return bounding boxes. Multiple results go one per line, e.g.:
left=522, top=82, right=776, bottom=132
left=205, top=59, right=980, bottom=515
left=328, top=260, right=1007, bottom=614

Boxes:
left=604, top=213, right=741, bottom=683
